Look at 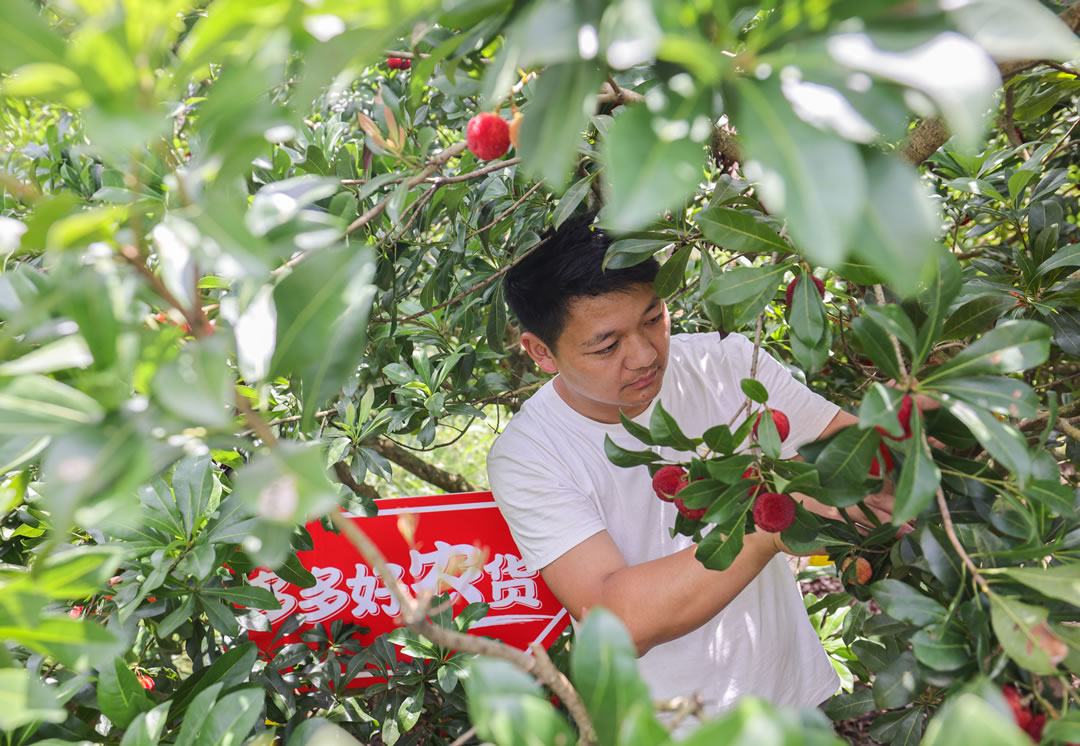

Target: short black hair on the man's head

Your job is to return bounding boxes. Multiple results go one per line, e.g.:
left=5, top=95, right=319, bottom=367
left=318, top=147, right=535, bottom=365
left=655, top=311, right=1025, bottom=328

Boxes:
left=503, top=213, right=660, bottom=350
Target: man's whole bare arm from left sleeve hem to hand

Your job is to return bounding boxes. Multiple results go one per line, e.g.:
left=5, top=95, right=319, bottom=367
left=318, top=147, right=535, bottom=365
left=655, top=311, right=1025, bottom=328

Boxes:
left=540, top=531, right=782, bottom=655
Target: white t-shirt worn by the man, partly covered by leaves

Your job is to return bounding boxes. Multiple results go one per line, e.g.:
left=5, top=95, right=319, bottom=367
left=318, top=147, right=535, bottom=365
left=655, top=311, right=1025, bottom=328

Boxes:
left=487, top=333, right=839, bottom=714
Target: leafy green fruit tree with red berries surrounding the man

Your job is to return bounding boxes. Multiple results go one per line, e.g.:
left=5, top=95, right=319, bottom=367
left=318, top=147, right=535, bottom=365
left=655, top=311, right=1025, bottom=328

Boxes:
left=0, top=0, right=1080, bottom=746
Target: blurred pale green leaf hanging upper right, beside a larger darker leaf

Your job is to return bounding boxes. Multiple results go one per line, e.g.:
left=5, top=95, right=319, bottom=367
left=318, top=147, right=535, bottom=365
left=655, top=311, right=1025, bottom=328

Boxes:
left=851, top=152, right=941, bottom=297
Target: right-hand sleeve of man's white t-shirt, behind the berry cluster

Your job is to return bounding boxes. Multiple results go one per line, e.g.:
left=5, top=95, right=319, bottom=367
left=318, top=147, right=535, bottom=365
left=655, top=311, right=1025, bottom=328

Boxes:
left=723, top=334, right=840, bottom=459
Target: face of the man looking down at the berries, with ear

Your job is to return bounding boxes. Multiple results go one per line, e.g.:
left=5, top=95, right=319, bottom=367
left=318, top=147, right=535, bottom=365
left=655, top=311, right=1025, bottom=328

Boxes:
left=526, top=284, right=671, bottom=422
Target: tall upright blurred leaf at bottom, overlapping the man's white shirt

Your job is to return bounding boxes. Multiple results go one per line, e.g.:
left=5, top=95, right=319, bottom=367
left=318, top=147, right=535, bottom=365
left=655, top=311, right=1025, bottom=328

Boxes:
left=574, top=607, right=652, bottom=744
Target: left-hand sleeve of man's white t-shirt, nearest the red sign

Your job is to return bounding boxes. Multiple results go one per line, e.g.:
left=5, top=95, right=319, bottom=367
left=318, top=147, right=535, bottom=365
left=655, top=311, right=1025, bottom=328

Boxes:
left=487, top=432, right=606, bottom=570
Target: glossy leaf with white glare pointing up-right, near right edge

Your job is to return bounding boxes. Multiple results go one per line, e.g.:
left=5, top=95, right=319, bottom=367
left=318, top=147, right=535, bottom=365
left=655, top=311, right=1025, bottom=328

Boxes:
left=922, top=321, right=1051, bottom=385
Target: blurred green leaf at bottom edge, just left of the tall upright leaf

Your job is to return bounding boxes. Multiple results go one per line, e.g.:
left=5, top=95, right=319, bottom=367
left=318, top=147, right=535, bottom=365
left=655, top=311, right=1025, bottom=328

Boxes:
left=463, top=660, right=578, bottom=746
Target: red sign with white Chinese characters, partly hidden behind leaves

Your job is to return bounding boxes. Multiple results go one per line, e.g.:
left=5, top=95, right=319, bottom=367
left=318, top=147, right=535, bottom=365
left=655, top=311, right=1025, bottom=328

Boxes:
left=241, top=492, right=570, bottom=686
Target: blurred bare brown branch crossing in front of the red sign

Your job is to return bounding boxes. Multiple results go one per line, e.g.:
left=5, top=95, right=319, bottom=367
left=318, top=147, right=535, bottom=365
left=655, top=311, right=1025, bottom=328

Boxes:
left=330, top=511, right=596, bottom=744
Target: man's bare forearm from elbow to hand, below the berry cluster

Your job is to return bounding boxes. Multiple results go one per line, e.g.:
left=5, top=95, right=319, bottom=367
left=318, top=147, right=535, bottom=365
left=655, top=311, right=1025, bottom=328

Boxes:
left=599, top=533, right=779, bottom=655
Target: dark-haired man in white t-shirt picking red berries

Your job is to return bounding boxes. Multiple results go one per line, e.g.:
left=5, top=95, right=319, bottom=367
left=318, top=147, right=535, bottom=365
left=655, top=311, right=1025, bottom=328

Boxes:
left=488, top=216, right=889, bottom=711
